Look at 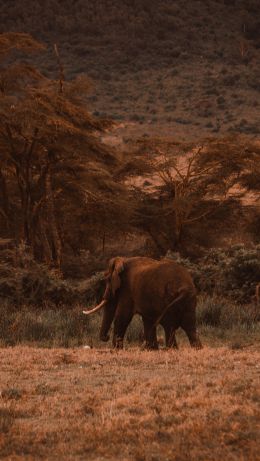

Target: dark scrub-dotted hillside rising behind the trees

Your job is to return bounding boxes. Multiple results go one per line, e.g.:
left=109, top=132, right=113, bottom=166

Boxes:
left=0, top=0, right=260, bottom=137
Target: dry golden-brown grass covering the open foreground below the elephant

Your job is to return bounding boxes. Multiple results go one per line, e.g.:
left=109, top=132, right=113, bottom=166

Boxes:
left=0, top=346, right=260, bottom=461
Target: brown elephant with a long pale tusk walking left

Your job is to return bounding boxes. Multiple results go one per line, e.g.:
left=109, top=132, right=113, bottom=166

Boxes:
left=83, top=256, right=202, bottom=349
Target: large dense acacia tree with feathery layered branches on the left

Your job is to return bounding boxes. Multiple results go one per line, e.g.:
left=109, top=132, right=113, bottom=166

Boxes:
left=0, top=33, right=133, bottom=267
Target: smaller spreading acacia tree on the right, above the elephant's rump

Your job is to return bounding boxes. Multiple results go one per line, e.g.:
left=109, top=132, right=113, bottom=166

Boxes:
left=134, top=137, right=260, bottom=252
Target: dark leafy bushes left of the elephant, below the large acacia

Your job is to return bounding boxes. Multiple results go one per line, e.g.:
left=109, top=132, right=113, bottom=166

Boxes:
left=0, top=241, right=103, bottom=307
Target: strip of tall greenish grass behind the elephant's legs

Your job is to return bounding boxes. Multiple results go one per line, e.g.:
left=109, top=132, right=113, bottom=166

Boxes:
left=0, top=295, right=260, bottom=347
